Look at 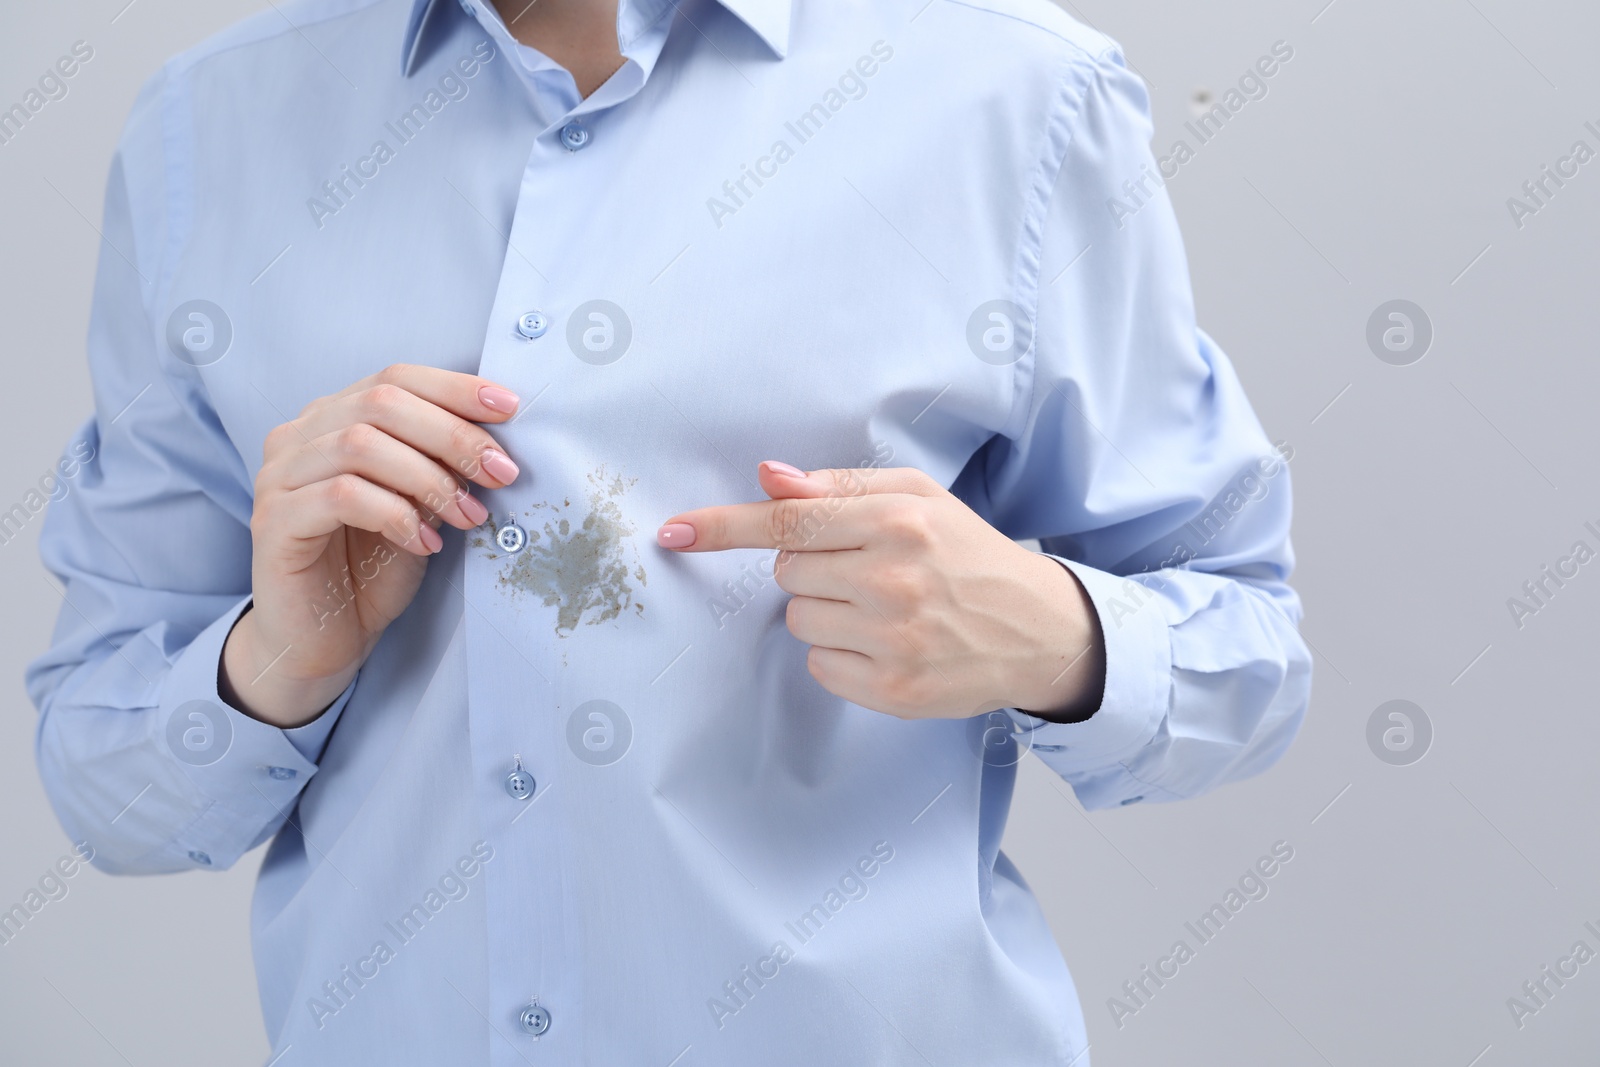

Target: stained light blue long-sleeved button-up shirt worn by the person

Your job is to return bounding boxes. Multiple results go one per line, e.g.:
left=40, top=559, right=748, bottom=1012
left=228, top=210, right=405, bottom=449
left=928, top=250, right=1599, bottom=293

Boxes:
left=29, top=0, right=1310, bottom=1067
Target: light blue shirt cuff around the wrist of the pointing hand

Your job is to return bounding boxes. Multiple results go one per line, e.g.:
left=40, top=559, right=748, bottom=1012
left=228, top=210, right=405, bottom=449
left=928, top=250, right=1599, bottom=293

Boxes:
left=1006, top=552, right=1173, bottom=776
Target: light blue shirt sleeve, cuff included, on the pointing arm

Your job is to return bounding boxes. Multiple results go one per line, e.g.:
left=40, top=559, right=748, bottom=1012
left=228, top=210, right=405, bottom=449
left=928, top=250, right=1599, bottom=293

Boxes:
left=963, top=41, right=1310, bottom=808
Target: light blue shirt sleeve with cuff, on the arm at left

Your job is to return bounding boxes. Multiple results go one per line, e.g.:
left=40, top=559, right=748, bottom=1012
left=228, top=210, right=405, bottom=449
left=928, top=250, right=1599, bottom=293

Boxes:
left=26, top=77, right=355, bottom=873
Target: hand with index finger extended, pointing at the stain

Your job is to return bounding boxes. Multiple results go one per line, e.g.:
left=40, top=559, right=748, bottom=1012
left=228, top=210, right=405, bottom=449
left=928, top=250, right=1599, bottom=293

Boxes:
left=658, top=461, right=1106, bottom=721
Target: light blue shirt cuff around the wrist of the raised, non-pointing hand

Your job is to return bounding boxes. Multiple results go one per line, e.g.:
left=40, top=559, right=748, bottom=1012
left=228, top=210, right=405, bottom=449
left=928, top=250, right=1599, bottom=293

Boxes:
left=157, top=597, right=355, bottom=869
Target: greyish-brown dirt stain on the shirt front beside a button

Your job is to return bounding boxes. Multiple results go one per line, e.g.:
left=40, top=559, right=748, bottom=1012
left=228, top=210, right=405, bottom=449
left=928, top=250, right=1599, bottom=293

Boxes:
left=486, top=467, right=646, bottom=637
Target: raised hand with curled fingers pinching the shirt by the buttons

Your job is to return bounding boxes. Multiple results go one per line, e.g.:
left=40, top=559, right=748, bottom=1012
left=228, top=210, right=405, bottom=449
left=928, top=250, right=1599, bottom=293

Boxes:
left=219, top=363, right=518, bottom=728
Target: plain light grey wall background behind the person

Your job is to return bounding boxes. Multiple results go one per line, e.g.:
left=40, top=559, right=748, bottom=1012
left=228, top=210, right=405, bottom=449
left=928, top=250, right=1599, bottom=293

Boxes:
left=0, top=0, right=1600, bottom=1067
